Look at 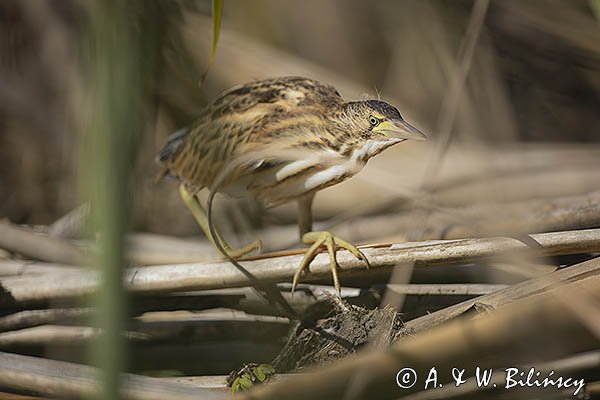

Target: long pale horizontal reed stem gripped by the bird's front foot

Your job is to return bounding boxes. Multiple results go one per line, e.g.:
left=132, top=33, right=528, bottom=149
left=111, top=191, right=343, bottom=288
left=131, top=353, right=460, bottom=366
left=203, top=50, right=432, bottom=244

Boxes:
left=0, top=229, right=600, bottom=307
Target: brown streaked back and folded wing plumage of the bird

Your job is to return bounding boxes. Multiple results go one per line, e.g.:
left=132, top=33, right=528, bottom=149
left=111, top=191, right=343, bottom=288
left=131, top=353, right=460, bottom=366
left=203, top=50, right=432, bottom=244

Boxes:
left=160, top=77, right=343, bottom=194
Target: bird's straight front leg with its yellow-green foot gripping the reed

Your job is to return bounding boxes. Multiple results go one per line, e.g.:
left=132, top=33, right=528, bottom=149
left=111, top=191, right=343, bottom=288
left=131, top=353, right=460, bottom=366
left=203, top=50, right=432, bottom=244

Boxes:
left=292, top=194, right=370, bottom=294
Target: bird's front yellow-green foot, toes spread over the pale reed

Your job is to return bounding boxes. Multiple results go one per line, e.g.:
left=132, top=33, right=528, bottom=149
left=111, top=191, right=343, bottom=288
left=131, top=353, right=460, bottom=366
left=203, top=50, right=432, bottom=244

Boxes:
left=292, top=231, right=370, bottom=295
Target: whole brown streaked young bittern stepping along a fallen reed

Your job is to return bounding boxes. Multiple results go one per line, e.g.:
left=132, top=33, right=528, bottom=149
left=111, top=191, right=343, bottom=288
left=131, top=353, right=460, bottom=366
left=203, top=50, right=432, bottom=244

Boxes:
left=158, top=77, right=425, bottom=292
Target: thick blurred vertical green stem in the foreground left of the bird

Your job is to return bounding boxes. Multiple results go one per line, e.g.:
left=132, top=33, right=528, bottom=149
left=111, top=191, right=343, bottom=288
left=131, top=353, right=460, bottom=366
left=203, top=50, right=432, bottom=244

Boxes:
left=80, top=0, right=143, bottom=399
